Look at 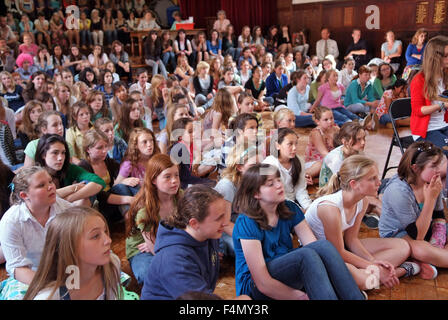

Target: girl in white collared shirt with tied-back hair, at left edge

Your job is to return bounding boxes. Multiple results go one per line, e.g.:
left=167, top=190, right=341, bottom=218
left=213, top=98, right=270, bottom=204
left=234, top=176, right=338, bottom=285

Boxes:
left=0, top=166, right=71, bottom=300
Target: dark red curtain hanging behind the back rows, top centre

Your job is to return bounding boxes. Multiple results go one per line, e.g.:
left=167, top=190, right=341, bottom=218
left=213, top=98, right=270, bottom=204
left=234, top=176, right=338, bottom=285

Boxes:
left=179, top=0, right=277, bottom=34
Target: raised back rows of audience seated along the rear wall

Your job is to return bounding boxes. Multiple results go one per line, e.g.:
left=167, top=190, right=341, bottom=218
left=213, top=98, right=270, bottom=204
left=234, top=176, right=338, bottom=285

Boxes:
left=0, top=1, right=427, bottom=79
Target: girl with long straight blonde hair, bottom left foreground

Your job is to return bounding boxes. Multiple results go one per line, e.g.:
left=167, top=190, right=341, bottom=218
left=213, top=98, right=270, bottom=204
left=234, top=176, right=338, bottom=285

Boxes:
left=24, top=207, right=123, bottom=300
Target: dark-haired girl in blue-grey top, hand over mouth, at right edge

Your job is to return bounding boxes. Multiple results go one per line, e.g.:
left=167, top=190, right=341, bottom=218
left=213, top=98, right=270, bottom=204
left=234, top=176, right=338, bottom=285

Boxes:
left=379, top=141, right=448, bottom=279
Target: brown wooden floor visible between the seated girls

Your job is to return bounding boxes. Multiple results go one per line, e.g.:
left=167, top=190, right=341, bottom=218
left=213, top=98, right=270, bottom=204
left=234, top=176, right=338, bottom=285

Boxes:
left=0, top=123, right=448, bottom=300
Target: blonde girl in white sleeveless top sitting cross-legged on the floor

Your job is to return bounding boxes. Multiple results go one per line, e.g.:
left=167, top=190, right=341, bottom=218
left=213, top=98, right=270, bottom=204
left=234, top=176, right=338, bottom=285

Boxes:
left=305, top=155, right=420, bottom=290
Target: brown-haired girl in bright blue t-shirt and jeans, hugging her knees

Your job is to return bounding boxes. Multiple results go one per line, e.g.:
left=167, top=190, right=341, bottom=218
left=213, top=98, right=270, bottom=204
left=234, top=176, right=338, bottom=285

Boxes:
left=233, top=164, right=364, bottom=300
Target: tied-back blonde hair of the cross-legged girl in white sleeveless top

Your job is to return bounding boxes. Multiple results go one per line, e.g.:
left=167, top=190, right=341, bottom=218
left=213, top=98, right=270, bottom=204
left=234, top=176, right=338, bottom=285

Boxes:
left=316, top=155, right=377, bottom=197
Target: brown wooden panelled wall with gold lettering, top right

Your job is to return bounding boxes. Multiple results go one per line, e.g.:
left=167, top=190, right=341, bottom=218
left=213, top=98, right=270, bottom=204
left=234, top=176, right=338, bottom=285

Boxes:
left=277, top=0, right=448, bottom=57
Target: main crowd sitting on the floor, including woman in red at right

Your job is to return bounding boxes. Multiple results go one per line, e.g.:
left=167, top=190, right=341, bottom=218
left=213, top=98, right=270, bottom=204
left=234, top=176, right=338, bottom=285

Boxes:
left=0, top=20, right=448, bottom=299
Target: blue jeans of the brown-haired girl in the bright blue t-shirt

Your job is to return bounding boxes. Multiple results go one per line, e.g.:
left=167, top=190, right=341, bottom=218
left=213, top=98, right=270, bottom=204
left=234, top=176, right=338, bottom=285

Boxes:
left=251, top=240, right=364, bottom=300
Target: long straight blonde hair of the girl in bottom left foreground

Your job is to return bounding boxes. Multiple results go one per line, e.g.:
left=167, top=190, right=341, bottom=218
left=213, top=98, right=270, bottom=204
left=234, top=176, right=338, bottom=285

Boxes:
left=24, top=207, right=123, bottom=300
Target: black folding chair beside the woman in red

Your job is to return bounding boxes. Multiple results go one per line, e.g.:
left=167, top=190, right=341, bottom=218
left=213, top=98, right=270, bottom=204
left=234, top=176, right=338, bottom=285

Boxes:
left=381, top=98, right=414, bottom=180
